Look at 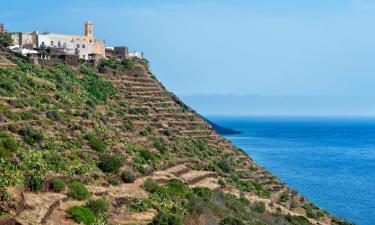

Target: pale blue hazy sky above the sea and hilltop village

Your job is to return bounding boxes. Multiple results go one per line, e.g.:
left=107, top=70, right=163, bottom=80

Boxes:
left=0, top=0, right=375, bottom=115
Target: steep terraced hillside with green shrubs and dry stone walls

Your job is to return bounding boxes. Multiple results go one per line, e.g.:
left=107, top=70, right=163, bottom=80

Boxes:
left=0, top=52, right=349, bottom=225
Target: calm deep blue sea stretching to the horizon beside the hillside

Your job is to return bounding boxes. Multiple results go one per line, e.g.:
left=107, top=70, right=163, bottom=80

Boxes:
left=208, top=117, right=375, bottom=225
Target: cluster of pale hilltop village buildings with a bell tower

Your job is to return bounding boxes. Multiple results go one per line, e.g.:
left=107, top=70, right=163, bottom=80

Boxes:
left=0, top=21, right=143, bottom=66
